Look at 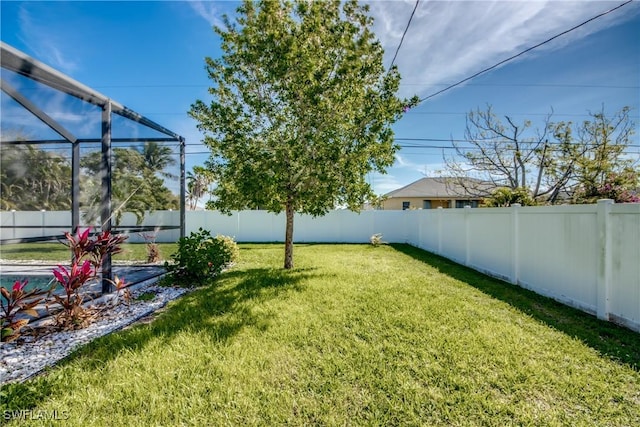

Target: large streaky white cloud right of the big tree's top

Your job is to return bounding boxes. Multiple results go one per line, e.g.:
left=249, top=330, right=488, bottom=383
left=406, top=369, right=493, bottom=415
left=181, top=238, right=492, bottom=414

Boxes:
left=370, top=0, right=640, bottom=96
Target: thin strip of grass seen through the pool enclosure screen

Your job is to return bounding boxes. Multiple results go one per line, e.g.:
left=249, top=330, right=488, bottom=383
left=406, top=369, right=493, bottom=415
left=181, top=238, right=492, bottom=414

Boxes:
left=0, top=242, right=178, bottom=262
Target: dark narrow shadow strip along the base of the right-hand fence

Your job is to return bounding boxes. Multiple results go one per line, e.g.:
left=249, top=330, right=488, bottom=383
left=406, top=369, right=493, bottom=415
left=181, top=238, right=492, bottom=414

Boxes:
left=390, top=244, right=640, bottom=371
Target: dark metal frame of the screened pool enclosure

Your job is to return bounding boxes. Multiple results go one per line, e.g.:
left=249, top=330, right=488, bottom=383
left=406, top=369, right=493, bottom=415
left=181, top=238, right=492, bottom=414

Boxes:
left=0, top=41, right=186, bottom=293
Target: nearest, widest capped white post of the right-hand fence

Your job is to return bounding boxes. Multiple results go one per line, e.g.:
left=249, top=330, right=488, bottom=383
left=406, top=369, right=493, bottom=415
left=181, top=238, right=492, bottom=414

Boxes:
left=596, top=199, right=613, bottom=320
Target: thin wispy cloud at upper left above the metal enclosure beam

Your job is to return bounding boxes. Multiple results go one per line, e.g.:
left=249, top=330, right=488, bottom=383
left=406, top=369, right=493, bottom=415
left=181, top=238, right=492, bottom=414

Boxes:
left=19, top=7, right=79, bottom=74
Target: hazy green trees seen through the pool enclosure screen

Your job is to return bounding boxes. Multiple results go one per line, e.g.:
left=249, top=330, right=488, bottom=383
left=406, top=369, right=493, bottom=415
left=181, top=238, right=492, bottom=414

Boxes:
left=0, top=141, right=180, bottom=222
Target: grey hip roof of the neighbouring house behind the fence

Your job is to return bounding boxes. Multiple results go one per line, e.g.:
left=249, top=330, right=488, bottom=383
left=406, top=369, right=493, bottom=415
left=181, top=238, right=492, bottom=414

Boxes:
left=385, top=177, right=493, bottom=199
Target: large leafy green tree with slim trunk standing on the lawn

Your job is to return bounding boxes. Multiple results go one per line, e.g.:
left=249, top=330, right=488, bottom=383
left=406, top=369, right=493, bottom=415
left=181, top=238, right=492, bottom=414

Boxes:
left=189, top=0, right=417, bottom=268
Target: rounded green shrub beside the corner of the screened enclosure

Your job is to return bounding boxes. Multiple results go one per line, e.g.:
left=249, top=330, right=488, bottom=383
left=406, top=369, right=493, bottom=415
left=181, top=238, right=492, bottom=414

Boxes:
left=165, top=228, right=239, bottom=286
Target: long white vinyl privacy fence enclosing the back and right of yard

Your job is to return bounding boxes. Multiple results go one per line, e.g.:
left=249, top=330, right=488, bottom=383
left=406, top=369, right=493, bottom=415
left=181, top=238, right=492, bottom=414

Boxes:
left=0, top=201, right=640, bottom=332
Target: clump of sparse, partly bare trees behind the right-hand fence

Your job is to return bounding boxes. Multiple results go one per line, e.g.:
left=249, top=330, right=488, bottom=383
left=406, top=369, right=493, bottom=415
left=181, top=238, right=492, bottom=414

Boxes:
left=445, top=106, right=637, bottom=203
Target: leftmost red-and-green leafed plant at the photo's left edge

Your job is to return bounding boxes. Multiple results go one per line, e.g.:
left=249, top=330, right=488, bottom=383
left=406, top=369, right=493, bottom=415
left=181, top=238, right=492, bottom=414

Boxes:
left=0, top=279, right=46, bottom=342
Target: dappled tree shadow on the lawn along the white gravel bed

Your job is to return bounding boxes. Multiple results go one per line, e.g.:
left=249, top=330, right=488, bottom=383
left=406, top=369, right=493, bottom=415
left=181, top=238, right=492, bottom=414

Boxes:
left=0, top=268, right=314, bottom=413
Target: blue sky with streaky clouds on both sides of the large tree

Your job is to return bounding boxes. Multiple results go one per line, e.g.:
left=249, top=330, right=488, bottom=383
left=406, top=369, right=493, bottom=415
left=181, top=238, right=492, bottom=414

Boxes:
left=0, top=0, right=640, bottom=194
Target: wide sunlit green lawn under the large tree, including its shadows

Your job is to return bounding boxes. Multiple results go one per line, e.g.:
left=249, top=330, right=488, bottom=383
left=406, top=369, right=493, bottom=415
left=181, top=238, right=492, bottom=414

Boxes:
left=1, top=245, right=640, bottom=426
